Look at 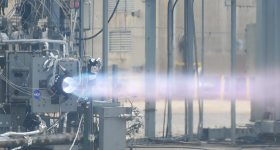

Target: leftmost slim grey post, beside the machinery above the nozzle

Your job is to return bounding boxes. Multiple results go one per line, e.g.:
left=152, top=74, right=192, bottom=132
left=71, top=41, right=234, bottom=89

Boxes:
left=79, top=0, right=84, bottom=62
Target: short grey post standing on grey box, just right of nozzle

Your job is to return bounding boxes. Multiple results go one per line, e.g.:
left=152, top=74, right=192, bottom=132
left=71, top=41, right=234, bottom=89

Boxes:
left=112, top=65, right=118, bottom=103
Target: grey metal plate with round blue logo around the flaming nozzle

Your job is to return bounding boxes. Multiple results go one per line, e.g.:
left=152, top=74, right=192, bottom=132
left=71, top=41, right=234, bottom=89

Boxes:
left=30, top=57, right=78, bottom=112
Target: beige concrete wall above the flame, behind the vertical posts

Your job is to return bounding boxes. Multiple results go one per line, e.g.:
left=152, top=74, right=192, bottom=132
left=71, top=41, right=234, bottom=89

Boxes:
left=85, top=0, right=256, bottom=76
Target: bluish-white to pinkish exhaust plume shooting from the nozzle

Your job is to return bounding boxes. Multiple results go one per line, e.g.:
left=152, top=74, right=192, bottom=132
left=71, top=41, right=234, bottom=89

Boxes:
left=61, top=74, right=249, bottom=100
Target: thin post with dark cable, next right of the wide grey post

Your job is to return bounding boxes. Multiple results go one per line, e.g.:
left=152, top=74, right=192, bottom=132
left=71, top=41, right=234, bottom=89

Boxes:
left=166, top=0, right=173, bottom=138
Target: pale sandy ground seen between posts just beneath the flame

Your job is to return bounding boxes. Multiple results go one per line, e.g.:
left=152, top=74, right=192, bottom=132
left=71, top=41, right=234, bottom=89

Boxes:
left=124, top=100, right=251, bottom=138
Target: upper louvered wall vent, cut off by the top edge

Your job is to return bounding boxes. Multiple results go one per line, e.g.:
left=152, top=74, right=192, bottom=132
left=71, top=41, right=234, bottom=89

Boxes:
left=108, top=0, right=134, bottom=14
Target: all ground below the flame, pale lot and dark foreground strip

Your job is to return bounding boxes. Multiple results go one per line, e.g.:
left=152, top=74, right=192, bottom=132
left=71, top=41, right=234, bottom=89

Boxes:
left=125, top=100, right=280, bottom=150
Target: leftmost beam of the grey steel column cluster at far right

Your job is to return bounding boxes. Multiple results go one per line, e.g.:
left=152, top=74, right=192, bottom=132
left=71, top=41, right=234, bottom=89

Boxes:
left=254, top=0, right=267, bottom=121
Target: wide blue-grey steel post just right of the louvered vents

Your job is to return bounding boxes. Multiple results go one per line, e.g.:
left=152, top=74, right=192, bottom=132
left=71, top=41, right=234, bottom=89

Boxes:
left=145, top=0, right=156, bottom=138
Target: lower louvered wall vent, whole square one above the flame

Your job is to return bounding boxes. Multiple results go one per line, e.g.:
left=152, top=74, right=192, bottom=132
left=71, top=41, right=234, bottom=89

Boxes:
left=109, top=31, right=131, bottom=52
